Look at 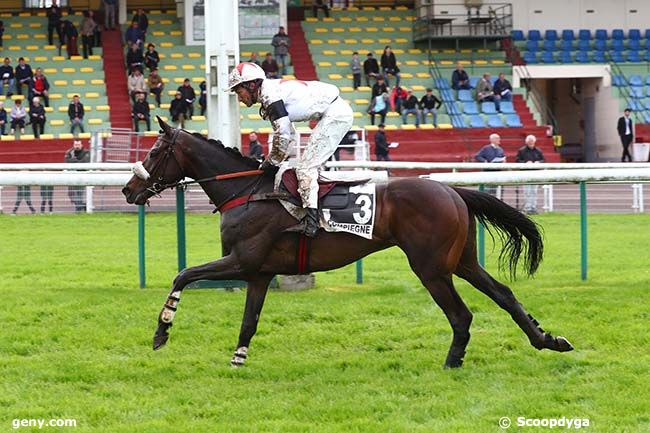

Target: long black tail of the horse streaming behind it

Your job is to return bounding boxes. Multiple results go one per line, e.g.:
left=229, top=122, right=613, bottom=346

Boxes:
left=453, top=187, right=544, bottom=278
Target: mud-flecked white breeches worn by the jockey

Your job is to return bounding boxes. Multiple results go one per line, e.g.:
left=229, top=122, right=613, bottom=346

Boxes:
left=296, top=97, right=353, bottom=209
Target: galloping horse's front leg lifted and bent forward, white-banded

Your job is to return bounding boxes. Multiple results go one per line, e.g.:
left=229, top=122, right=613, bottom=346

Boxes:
left=153, top=254, right=242, bottom=350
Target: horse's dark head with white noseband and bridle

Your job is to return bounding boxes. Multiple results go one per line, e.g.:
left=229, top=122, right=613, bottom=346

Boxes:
left=122, top=116, right=185, bottom=204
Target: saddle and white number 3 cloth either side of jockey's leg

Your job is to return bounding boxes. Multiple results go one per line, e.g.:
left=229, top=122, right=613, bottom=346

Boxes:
left=276, top=169, right=376, bottom=239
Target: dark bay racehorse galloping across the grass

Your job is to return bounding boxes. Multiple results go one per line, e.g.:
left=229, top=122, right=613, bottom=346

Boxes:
left=122, top=118, right=573, bottom=368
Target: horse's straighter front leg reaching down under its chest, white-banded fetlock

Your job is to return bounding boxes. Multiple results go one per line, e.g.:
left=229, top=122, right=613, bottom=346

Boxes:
left=230, top=275, right=273, bottom=367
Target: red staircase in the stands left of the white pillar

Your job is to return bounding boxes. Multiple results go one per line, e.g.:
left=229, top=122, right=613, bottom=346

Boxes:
left=102, top=30, right=133, bottom=129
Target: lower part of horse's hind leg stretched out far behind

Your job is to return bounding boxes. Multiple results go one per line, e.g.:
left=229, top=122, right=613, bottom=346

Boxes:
left=456, top=257, right=573, bottom=352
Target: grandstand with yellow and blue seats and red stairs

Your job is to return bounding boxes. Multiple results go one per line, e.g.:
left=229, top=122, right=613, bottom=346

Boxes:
left=0, top=0, right=650, bottom=162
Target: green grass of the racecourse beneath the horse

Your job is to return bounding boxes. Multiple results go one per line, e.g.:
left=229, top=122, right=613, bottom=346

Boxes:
left=0, top=214, right=650, bottom=433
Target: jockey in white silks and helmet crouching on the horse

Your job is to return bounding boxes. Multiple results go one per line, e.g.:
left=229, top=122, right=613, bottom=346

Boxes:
left=228, top=62, right=353, bottom=237
